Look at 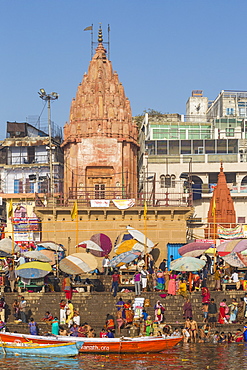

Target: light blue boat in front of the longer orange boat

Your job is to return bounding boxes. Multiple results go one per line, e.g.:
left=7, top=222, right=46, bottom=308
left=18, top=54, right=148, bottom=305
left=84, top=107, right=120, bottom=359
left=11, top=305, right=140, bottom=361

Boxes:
left=0, top=341, right=84, bottom=357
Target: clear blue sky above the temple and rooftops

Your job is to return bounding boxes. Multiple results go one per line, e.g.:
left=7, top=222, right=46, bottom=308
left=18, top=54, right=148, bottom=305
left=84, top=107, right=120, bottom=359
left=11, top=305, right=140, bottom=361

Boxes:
left=0, top=0, right=247, bottom=140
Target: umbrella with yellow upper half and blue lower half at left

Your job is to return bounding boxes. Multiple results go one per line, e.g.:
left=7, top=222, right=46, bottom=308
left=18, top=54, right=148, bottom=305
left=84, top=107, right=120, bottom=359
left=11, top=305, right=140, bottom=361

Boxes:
left=15, top=261, right=52, bottom=279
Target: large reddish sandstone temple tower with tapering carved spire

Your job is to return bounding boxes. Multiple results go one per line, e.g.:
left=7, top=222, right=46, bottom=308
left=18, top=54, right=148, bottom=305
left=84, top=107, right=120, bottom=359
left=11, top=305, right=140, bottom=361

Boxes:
left=62, top=29, right=138, bottom=200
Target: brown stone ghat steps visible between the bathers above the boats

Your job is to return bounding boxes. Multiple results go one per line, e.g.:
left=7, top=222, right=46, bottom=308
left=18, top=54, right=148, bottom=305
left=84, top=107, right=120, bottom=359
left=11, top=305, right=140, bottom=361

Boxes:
left=1, top=291, right=244, bottom=335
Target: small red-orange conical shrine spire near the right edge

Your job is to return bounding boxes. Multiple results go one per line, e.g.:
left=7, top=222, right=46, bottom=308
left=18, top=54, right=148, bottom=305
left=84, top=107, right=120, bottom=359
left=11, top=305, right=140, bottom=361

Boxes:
left=205, top=163, right=236, bottom=239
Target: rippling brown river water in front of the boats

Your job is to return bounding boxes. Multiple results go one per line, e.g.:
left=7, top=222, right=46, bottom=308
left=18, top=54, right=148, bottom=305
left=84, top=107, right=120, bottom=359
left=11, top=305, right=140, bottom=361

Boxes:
left=0, top=343, right=247, bottom=370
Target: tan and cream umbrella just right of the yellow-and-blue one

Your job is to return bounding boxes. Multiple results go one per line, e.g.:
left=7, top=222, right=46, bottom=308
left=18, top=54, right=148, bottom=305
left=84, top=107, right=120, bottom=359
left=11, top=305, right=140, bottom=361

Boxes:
left=59, top=253, right=98, bottom=275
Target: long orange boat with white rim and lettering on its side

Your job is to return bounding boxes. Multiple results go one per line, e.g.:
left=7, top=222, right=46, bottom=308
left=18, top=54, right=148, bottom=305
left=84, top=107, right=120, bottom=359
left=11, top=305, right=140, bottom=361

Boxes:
left=0, top=332, right=182, bottom=354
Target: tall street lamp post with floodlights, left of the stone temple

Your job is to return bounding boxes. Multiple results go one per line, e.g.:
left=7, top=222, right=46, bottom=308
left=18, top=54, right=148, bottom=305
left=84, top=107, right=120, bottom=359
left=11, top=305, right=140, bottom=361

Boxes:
left=38, top=89, right=59, bottom=197
